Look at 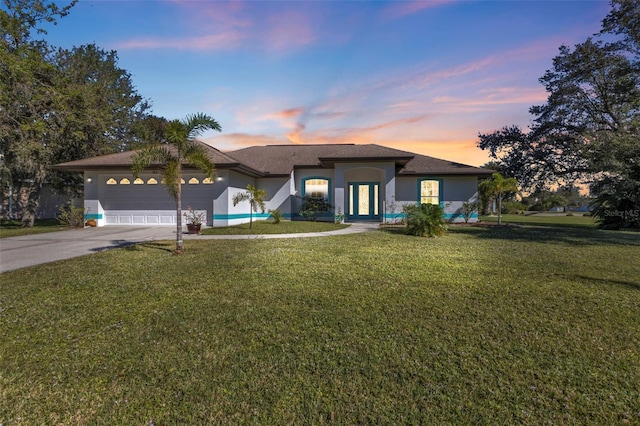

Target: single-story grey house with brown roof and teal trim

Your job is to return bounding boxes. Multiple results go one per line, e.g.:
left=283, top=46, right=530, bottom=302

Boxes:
left=56, top=143, right=493, bottom=226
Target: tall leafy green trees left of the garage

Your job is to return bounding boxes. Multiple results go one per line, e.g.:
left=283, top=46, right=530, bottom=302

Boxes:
left=0, top=0, right=166, bottom=226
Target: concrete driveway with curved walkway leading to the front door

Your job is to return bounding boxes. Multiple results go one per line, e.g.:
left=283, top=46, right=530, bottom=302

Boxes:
left=0, top=223, right=378, bottom=273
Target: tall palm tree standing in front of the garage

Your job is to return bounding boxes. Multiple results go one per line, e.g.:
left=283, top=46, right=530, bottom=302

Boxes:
left=131, top=113, right=222, bottom=253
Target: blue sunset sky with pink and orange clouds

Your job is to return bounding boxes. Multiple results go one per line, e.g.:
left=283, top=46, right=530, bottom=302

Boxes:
left=47, top=0, right=609, bottom=165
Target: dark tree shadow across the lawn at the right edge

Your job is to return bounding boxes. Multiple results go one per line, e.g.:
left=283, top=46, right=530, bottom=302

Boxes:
left=449, top=225, right=640, bottom=246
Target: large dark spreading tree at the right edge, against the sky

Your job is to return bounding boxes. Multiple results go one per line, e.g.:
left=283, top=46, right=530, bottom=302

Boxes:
left=478, top=0, right=640, bottom=226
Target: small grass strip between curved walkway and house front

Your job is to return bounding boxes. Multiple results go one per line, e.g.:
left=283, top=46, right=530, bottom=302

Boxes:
left=201, top=220, right=349, bottom=235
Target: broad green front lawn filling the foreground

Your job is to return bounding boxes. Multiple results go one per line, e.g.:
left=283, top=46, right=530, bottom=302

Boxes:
left=0, top=226, right=640, bottom=425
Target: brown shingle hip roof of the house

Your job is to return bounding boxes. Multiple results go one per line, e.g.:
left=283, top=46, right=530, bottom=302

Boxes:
left=55, top=143, right=493, bottom=176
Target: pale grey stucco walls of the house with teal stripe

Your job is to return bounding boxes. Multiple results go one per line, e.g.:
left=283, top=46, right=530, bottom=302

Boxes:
left=79, top=166, right=477, bottom=226
